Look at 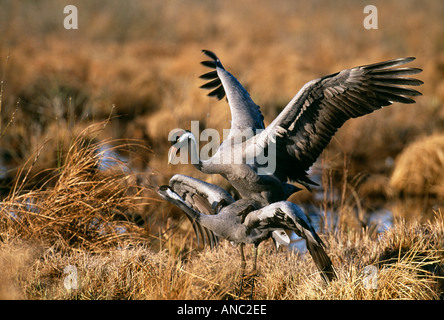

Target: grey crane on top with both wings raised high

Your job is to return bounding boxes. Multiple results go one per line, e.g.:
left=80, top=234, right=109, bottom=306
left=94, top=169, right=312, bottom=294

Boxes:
left=168, top=50, right=423, bottom=206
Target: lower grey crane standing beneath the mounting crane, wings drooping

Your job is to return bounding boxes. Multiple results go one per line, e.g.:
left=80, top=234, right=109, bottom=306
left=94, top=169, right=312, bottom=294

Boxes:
left=157, top=175, right=336, bottom=282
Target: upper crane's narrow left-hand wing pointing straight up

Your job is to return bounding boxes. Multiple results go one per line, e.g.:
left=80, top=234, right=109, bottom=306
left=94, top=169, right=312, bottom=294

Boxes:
left=200, top=50, right=265, bottom=133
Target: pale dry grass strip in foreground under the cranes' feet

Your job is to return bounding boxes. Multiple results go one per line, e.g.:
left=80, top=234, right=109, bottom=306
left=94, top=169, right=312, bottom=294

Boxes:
left=0, top=212, right=444, bottom=300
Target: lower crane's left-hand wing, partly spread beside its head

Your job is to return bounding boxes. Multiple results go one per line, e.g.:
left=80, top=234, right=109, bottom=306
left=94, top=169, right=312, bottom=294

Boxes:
left=169, top=174, right=234, bottom=248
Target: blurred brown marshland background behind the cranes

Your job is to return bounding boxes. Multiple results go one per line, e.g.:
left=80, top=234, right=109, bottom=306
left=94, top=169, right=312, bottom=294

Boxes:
left=0, top=0, right=444, bottom=222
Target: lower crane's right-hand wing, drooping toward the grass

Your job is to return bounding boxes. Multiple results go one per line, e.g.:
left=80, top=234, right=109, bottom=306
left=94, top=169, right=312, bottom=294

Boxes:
left=244, top=201, right=336, bottom=282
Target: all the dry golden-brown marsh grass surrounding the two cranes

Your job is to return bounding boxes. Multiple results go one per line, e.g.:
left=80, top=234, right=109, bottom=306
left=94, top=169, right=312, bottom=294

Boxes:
left=0, top=0, right=444, bottom=299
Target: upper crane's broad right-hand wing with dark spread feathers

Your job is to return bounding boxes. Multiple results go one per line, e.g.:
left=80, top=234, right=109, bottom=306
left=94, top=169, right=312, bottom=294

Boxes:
left=260, top=57, right=423, bottom=188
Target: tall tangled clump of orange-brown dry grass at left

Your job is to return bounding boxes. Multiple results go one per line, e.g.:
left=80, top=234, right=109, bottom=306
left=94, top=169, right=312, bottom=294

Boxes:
left=0, top=124, right=156, bottom=251
